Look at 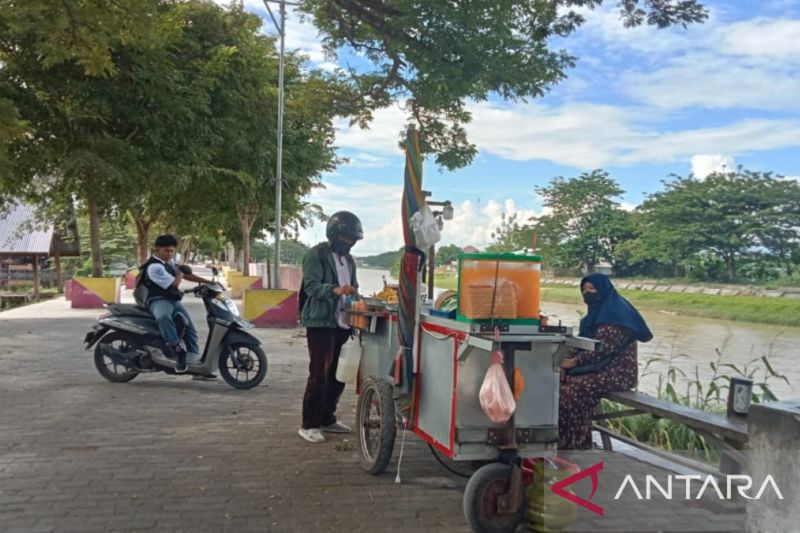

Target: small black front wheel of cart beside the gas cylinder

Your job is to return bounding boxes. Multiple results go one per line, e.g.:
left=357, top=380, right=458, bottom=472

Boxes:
left=463, top=463, right=525, bottom=533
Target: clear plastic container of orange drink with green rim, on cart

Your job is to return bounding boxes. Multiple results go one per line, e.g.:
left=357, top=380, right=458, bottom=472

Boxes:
left=458, top=254, right=542, bottom=324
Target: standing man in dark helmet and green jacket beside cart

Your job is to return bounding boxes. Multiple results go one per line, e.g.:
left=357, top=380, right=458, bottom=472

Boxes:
left=298, top=211, right=364, bottom=443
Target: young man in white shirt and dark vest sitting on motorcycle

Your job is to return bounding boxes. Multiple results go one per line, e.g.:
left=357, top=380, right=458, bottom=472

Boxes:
left=136, top=235, right=214, bottom=373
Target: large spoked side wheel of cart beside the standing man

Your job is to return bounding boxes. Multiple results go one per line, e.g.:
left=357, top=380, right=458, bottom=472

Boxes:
left=356, top=377, right=397, bottom=475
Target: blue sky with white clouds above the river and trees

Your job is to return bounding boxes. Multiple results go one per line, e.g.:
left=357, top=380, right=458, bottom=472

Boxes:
left=219, top=0, right=800, bottom=255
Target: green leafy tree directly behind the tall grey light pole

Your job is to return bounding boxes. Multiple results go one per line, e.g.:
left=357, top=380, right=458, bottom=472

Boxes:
left=177, top=5, right=337, bottom=274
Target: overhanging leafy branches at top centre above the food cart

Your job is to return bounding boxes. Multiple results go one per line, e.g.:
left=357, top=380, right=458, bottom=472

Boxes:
left=301, top=0, right=707, bottom=169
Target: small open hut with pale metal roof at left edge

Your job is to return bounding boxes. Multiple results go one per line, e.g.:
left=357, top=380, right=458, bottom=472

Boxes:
left=0, top=200, right=80, bottom=298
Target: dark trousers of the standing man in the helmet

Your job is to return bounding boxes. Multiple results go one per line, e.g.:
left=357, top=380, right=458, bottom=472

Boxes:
left=303, top=328, right=350, bottom=429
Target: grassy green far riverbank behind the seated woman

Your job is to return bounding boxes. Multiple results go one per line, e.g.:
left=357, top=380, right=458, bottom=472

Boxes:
left=542, top=286, right=800, bottom=327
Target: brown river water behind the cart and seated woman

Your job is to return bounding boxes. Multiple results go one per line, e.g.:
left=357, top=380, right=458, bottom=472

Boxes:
left=358, top=269, right=800, bottom=400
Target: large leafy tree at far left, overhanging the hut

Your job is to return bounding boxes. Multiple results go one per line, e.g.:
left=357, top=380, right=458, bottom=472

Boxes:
left=0, top=0, right=166, bottom=276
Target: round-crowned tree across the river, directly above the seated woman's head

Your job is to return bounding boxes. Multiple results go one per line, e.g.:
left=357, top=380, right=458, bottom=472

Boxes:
left=533, top=170, right=630, bottom=272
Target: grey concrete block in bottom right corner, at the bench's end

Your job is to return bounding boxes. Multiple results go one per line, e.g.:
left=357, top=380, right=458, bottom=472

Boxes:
left=747, top=400, right=800, bottom=532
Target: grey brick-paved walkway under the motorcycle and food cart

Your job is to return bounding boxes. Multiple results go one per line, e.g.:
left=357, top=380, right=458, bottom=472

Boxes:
left=0, top=280, right=743, bottom=532
